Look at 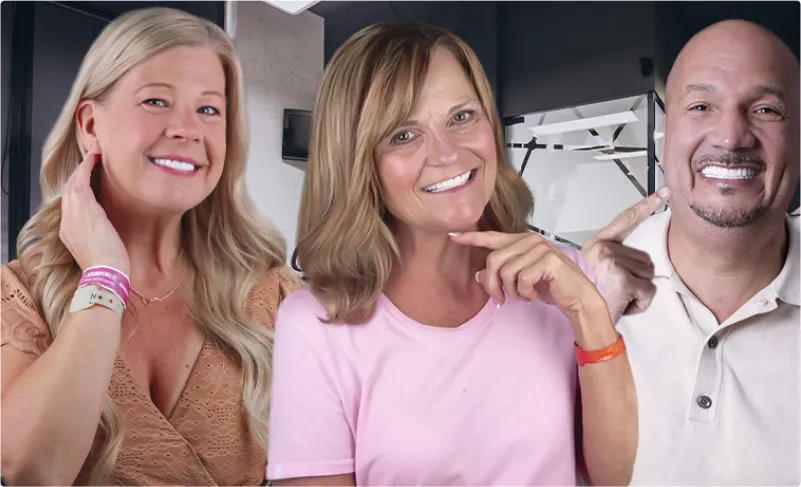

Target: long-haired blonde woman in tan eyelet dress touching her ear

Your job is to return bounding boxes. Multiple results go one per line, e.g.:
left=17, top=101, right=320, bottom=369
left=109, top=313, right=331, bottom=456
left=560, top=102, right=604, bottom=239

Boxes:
left=0, top=8, right=296, bottom=485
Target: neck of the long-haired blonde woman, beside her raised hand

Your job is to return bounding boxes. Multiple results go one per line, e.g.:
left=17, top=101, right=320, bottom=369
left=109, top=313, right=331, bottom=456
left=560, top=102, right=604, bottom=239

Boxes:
left=100, top=191, right=182, bottom=296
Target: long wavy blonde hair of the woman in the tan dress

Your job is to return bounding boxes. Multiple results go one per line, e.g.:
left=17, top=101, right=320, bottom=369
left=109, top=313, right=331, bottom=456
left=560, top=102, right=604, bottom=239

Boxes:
left=17, top=8, right=285, bottom=484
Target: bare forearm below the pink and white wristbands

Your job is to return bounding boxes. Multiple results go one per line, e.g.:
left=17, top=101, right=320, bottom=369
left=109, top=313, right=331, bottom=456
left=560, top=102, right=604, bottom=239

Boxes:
left=2, top=306, right=121, bottom=485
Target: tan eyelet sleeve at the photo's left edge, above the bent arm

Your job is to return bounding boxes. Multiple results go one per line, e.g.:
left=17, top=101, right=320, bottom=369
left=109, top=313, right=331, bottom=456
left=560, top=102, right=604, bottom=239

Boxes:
left=0, top=261, right=53, bottom=356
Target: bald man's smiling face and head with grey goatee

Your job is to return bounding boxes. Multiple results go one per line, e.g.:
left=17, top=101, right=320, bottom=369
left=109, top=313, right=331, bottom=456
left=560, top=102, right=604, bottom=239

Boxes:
left=663, top=22, right=799, bottom=228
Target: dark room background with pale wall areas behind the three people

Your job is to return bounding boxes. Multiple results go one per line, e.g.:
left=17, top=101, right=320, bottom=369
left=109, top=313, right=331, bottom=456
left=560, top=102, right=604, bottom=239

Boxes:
left=0, top=0, right=800, bottom=262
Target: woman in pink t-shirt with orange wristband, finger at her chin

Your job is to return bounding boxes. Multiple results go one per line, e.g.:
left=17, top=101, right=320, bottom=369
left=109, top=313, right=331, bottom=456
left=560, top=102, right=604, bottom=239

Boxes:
left=267, top=23, right=637, bottom=485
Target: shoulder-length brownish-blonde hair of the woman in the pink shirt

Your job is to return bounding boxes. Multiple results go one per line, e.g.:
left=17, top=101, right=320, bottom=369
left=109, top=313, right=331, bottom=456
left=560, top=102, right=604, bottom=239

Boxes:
left=297, top=22, right=534, bottom=323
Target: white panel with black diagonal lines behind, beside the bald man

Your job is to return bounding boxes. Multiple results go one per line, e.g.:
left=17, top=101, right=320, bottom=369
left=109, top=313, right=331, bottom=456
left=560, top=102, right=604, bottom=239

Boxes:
left=505, top=95, right=664, bottom=245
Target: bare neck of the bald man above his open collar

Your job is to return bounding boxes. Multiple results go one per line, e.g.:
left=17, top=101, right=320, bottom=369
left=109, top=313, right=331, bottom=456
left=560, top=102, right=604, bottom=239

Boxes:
left=668, top=209, right=789, bottom=323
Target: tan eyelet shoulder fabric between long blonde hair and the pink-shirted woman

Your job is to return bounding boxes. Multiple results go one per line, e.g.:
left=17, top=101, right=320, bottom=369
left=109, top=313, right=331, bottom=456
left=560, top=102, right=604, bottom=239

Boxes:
left=243, top=266, right=303, bottom=328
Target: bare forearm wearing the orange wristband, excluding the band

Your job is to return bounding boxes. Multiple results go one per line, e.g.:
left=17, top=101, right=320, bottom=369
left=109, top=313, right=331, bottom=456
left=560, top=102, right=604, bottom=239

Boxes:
left=574, top=309, right=638, bottom=485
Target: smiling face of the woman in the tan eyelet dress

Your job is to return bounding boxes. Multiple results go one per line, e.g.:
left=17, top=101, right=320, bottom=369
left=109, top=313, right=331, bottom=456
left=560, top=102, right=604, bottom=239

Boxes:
left=78, top=47, right=226, bottom=214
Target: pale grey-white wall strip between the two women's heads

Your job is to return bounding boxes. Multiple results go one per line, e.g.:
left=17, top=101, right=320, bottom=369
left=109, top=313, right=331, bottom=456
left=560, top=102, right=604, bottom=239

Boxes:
left=234, top=1, right=324, bottom=259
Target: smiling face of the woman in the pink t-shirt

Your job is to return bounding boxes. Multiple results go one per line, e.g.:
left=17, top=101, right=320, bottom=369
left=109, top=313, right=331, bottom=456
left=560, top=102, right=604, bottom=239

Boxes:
left=375, top=47, right=497, bottom=232
